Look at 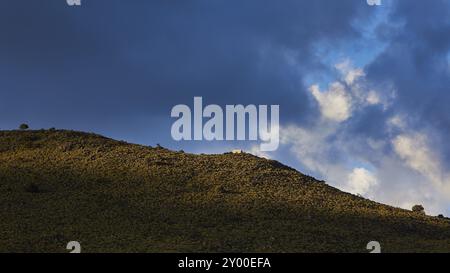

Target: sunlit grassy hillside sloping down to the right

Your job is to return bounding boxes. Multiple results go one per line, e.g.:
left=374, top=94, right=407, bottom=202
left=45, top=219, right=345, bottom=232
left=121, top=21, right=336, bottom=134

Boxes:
left=0, top=130, right=450, bottom=252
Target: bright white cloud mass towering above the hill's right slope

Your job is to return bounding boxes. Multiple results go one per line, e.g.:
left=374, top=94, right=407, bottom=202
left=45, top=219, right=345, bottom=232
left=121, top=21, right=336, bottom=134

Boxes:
left=280, top=61, right=450, bottom=215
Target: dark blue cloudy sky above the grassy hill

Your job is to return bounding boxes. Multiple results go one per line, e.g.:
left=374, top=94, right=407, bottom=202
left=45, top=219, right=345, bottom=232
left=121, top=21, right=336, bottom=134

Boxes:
left=0, top=0, right=450, bottom=213
